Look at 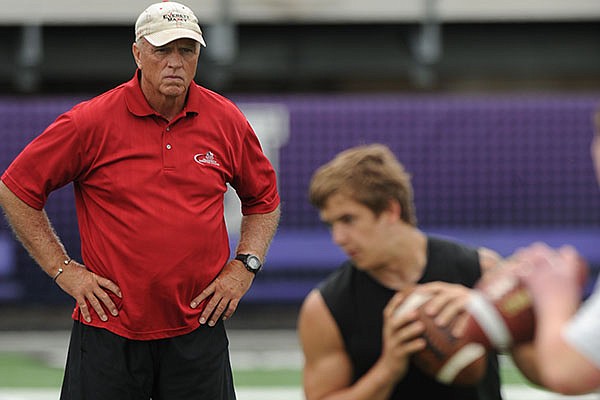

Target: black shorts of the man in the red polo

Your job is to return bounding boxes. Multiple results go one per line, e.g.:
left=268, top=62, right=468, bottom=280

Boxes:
left=60, top=321, right=236, bottom=400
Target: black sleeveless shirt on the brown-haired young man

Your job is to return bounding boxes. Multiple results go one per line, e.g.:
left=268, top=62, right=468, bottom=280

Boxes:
left=318, top=237, right=502, bottom=400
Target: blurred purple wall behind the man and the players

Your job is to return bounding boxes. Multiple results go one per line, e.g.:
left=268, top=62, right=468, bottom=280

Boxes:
left=0, top=94, right=600, bottom=301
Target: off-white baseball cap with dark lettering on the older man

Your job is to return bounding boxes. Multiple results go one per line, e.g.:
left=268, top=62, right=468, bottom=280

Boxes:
left=135, top=1, right=206, bottom=47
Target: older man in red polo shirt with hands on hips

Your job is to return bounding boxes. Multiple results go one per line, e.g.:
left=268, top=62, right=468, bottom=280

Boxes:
left=0, top=2, right=279, bottom=400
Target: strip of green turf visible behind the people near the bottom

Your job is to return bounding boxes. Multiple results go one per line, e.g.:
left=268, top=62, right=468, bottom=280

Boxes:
left=0, top=353, right=528, bottom=388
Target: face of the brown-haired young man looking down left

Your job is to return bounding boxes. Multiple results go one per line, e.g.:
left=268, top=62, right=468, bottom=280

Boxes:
left=320, top=193, right=389, bottom=270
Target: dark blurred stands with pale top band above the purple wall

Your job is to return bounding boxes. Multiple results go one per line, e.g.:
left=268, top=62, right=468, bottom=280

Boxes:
left=0, top=0, right=600, bottom=95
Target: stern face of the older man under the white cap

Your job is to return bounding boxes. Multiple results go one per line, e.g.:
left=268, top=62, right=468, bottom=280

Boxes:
left=134, top=39, right=200, bottom=97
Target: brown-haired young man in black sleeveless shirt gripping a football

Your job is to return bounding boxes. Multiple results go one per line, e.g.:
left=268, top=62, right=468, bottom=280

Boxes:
left=298, top=144, right=510, bottom=400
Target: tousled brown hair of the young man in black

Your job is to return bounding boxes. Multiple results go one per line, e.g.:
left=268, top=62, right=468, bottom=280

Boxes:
left=309, top=143, right=417, bottom=226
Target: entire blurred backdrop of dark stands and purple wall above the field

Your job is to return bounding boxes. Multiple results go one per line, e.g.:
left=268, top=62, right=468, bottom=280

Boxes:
left=0, top=0, right=600, bottom=396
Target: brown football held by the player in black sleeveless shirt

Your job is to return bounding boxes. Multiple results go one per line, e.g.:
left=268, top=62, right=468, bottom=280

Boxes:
left=395, top=288, right=487, bottom=386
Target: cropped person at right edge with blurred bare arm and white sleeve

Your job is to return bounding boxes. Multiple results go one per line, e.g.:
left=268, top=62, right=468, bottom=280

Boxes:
left=512, top=112, right=600, bottom=395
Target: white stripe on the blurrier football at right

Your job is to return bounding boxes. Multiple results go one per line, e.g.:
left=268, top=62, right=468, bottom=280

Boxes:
left=467, top=292, right=512, bottom=350
